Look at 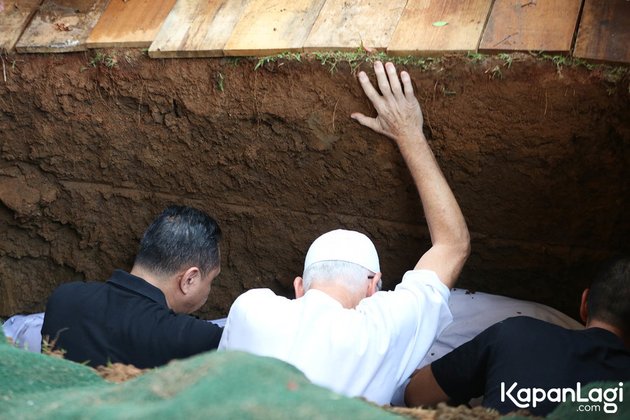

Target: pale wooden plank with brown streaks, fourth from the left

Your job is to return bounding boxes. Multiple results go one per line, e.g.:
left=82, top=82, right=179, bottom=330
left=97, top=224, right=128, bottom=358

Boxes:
left=149, top=0, right=250, bottom=58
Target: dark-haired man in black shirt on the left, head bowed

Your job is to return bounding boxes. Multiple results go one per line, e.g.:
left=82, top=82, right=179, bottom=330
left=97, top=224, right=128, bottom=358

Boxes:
left=42, top=206, right=223, bottom=368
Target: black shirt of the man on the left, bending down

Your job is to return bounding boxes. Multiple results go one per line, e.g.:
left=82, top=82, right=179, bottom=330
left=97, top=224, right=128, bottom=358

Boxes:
left=42, top=270, right=223, bottom=368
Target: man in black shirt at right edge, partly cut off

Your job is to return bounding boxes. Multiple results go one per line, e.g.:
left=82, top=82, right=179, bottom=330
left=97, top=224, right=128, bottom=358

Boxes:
left=405, top=258, right=630, bottom=415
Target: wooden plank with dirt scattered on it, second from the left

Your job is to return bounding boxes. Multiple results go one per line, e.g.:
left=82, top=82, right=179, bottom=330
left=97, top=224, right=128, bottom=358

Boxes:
left=15, top=0, right=109, bottom=53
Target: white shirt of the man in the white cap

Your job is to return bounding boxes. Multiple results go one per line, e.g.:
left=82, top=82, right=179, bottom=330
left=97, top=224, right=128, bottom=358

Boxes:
left=219, top=270, right=452, bottom=404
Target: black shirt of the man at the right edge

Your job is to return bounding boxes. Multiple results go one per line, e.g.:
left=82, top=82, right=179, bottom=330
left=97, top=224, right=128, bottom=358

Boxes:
left=431, top=316, right=630, bottom=415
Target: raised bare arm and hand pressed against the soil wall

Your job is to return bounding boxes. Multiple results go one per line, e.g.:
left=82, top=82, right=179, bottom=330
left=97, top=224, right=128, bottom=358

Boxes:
left=352, top=61, right=470, bottom=287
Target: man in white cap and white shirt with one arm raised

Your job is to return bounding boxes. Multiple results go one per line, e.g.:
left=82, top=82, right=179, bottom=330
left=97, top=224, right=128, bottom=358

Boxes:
left=219, top=62, right=470, bottom=404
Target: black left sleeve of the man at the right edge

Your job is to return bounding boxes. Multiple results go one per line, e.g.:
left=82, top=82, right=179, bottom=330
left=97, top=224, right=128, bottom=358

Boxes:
left=431, top=323, right=500, bottom=405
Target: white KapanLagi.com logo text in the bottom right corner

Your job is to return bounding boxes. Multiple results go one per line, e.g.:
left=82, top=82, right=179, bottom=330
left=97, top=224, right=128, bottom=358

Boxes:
left=501, top=382, right=623, bottom=414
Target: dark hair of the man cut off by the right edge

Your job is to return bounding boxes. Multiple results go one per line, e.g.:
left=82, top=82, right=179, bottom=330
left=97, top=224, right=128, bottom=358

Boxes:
left=588, top=257, right=630, bottom=336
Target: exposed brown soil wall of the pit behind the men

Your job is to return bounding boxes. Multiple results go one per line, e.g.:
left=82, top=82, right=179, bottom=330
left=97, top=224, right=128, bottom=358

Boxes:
left=0, top=51, right=630, bottom=317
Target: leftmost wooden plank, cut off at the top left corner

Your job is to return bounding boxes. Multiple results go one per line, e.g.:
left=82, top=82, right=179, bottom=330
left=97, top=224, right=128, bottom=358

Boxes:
left=0, top=0, right=41, bottom=53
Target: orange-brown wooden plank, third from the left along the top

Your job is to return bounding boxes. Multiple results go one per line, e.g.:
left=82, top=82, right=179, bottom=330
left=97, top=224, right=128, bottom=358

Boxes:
left=87, top=0, right=175, bottom=48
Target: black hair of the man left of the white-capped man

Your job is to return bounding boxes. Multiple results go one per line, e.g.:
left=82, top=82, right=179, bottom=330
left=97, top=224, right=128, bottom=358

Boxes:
left=135, top=206, right=221, bottom=275
